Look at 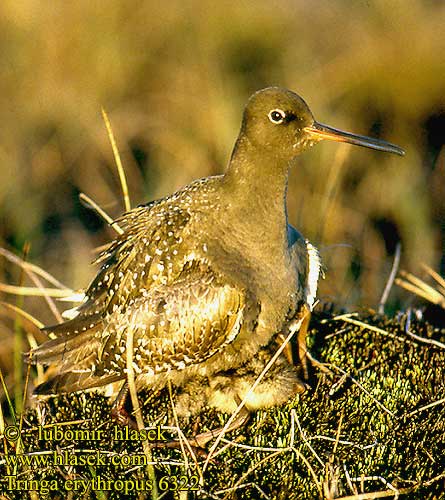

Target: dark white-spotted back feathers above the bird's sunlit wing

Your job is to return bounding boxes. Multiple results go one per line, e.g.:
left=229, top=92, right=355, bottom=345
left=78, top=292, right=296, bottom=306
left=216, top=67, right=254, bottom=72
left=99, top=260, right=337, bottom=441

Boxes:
left=54, top=199, right=190, bottom=328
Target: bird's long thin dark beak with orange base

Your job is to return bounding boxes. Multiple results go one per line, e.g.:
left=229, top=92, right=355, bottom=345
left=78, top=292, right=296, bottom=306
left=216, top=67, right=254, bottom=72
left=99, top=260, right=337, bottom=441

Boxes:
left=304, top=122, right=405, bottom=156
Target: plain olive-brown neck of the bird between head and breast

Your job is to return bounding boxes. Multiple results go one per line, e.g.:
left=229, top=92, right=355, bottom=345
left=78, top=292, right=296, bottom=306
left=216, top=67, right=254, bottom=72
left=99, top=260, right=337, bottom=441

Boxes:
left=224, top=136, right=289, bottom=241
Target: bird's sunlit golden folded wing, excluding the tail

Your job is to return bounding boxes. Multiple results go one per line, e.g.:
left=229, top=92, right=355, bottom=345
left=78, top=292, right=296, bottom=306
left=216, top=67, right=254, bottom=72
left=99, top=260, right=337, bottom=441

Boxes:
left=101, top=262, right=246, bottom=374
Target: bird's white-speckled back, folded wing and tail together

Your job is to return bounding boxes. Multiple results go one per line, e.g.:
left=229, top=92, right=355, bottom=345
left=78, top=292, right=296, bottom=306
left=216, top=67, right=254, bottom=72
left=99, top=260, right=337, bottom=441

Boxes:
left=29, top=177, right=274, bottom=393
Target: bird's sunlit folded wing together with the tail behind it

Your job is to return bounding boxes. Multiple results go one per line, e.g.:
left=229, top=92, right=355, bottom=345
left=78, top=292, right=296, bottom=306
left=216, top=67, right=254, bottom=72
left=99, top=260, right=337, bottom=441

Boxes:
left=29, top=262, right=246, bottom=394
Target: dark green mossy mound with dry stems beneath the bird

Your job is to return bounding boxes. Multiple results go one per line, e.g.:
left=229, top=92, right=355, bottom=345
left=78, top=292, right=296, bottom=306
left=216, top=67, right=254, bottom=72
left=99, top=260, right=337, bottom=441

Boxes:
left=0, top=313, right=445, bottom=499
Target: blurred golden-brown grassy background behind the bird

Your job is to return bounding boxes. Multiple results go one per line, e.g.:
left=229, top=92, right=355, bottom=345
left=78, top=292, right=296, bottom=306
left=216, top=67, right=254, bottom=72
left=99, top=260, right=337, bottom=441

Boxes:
left=0, top=0, right=445, bottom=338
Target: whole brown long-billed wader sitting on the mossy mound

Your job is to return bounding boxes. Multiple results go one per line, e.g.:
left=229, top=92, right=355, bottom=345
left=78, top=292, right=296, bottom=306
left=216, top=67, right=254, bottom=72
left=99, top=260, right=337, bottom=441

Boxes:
left=25, top=87, right=404, bottom=424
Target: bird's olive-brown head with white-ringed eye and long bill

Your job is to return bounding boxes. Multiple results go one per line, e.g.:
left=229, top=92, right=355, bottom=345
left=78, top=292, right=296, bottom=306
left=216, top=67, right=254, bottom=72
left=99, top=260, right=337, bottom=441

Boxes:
left=242, top=87, right=405, bottom=160
